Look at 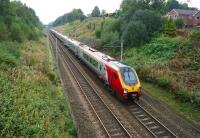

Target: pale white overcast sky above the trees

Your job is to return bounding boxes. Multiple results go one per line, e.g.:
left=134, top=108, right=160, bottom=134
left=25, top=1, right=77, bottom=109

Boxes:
left=16, top=0, right=200, bottom=24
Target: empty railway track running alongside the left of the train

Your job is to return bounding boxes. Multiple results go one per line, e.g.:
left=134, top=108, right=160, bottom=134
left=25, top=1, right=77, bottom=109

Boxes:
left=49, top=33, right=131, bottom=138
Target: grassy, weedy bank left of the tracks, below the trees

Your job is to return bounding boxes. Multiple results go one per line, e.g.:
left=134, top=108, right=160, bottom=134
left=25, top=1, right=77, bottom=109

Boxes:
left=0, top=39, right=76, bottom=137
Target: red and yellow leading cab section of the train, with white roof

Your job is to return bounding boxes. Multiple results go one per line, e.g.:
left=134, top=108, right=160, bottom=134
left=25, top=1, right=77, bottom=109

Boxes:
left=106, top=61, right=142, bottom=100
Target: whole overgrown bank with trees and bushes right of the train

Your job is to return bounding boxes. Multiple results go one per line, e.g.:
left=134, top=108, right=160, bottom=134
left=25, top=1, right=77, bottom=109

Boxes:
left=54, top=0, right=200, bottom=123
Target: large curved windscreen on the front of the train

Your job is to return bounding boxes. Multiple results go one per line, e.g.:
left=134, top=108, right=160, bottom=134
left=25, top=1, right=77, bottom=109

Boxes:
left=121, top=67, right=137, bottom=86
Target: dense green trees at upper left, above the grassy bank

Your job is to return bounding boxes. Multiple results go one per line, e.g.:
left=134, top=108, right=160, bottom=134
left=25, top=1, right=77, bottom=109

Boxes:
left=0, top=0, right=42, bottom=42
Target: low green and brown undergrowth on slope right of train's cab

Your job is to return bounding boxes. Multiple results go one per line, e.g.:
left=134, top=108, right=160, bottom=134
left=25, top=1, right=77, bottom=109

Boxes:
left=124, top=37, right=200, bottom=107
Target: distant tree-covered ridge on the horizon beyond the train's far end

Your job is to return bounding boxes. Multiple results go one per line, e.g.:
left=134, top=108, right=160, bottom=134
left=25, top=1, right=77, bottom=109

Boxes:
left=49, top=9, right=86, bottom=26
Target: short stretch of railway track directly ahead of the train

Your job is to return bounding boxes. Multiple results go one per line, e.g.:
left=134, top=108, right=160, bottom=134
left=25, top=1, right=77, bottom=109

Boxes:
left=128, top=102, right=177, bottom=138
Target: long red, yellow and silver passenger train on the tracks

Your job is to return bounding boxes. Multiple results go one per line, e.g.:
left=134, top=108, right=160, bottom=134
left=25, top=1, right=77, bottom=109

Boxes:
left=50, top=30, right=142, bottom=100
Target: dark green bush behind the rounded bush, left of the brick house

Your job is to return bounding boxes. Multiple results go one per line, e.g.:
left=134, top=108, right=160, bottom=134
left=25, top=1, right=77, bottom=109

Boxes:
left=132, top=10, right=162, bottom=35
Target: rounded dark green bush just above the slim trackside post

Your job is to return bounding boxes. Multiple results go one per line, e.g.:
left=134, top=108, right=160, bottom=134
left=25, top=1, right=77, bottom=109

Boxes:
left=123, top=22, right=148, bottom=46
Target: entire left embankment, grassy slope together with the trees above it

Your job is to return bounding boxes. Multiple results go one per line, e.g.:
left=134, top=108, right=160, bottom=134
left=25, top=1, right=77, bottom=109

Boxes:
left=0, top=0, right=77, bottom=137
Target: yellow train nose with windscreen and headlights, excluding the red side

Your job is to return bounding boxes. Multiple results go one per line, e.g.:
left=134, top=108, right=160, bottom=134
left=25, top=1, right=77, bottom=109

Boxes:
left=120, top=66, right=142, bottom=100
